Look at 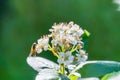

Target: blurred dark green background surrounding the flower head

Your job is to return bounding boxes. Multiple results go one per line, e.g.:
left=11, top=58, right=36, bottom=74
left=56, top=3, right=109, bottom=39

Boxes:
left=0, top=0, right=120, bottom=80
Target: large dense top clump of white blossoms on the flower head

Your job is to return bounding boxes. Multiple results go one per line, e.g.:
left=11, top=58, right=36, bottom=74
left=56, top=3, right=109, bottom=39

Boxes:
left=50, top=22, right=84, bottom=46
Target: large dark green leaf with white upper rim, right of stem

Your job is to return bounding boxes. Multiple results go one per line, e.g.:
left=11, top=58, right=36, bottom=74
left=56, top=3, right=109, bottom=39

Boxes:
left=76, top=61, right=120, bottom=77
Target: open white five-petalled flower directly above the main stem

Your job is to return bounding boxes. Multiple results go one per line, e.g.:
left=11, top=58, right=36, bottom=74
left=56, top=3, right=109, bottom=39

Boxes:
left=57, top=51, right=74, bottom=66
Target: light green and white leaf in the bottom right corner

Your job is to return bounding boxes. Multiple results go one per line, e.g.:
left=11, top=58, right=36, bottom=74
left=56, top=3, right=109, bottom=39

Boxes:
left=101, top=71, right=120, bottom=80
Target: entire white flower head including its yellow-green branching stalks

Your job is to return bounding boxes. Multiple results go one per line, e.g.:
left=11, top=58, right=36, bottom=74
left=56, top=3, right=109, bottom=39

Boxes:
left=33, top=22, right=88, bottom=74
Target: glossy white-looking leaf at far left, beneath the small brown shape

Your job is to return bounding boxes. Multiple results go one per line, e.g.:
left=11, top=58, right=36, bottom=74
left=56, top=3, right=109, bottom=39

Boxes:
left=27, top=56, right=59, bottom=72
